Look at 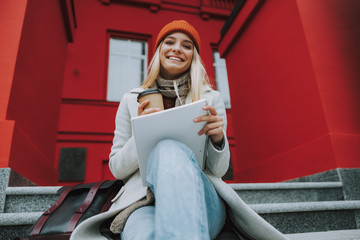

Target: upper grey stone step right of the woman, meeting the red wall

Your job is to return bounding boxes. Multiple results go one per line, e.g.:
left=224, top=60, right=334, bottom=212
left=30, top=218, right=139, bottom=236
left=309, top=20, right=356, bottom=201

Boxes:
left=230, top=182, right=344, bottom=204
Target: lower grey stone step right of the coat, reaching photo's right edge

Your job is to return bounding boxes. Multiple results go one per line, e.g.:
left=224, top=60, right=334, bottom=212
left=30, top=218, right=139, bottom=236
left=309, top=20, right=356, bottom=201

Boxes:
left=249, top=201, right=360, bottom=233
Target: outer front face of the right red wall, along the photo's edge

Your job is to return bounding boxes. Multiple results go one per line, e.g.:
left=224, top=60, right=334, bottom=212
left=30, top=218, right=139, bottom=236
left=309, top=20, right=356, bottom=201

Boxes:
left=298, top=0, right=360, bottom=168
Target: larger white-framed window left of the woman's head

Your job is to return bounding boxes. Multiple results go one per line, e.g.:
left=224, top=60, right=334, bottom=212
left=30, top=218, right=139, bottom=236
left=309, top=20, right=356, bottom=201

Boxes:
left=106, top=37, right=148, bottom=102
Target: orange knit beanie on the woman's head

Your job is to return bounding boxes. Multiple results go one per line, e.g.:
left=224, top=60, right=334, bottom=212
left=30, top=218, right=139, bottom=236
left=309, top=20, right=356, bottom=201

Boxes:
left=155, top=20, right=201, bottom=52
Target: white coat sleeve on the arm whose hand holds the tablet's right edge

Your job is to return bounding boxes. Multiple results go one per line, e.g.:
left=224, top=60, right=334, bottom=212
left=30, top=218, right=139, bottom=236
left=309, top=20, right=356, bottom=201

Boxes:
left=206, top=91, right=230, bottom=178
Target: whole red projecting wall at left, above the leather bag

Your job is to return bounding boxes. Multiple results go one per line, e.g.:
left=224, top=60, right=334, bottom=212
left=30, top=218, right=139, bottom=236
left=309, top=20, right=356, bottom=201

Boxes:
left=0, top=0, right=72, bottom=184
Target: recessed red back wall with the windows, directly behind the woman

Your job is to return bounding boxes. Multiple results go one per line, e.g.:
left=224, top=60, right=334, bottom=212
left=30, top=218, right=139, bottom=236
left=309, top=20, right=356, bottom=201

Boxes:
left=55, top=0, right=234, bottom=184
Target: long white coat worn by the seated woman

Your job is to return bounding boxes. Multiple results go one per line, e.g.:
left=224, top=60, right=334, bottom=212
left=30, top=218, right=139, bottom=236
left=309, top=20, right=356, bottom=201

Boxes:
left=70, top=87, right=287, bottom=240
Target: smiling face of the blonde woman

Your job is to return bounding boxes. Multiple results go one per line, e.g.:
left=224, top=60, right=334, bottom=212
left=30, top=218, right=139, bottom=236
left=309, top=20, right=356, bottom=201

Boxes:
left=160, top=32, right=194, bottom=80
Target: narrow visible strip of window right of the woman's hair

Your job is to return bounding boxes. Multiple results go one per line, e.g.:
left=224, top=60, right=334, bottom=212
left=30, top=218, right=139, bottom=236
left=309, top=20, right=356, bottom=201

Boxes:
left=214, top=51, right=231, bottom=108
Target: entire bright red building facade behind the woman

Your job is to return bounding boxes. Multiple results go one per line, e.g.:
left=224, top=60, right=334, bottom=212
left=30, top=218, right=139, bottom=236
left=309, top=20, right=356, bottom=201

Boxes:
left=0, top=0, right=360, bottom=185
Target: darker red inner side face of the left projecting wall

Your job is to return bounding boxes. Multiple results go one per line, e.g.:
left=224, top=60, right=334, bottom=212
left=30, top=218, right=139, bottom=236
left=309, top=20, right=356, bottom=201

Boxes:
left=0, top=0, right=67, bottom=184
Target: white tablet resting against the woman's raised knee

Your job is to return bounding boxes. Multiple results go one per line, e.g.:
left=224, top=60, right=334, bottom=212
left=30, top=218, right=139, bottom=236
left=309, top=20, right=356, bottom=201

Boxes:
left=131, top=99, right=208, bottom=186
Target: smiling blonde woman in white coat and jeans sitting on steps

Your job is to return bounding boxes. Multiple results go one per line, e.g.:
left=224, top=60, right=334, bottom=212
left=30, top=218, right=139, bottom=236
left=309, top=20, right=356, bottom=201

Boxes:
left=71, top=20, right=286, bottom=240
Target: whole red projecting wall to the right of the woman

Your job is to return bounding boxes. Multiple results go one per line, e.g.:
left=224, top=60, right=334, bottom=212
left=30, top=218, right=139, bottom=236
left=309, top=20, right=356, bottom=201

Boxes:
left=220, top=0, right=360, bottom=182
